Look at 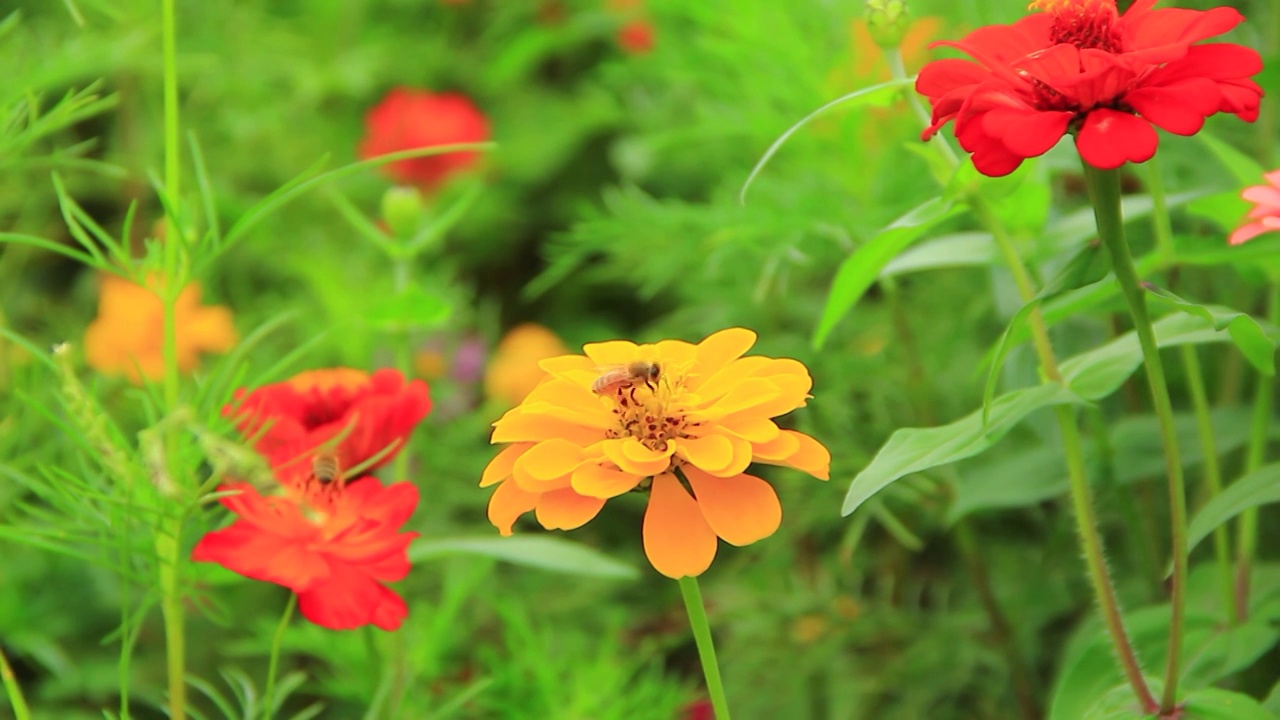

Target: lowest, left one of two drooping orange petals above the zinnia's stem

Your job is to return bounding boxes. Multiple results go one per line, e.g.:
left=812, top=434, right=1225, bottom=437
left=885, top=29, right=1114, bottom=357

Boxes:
left=644, top=473, right=716, bottom=578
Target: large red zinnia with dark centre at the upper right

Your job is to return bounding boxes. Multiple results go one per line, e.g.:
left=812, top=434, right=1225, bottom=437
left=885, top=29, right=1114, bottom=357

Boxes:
left=915, top=0, right=1262, bottom=177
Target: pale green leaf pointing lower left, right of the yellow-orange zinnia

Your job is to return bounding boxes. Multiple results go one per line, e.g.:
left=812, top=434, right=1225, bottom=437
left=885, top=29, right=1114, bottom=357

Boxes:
left=841, top=383, right=1080, bottom=515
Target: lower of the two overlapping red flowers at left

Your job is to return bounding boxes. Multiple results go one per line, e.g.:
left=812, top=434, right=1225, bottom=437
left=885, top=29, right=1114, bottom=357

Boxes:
left=191, top=478, right=417, bottom=630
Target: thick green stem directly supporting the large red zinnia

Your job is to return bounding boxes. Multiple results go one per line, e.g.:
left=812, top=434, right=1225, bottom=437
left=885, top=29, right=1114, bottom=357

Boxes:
left=1083, top=163, right=1187, bottom=715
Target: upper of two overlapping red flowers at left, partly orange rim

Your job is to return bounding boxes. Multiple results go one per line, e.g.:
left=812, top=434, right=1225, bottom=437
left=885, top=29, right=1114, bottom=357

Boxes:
left=223, top=368, right=431, bottom=484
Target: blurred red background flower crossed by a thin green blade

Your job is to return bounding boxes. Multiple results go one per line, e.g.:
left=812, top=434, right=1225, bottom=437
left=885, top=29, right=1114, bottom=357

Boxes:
left=358, top=87, right=489, bottom=192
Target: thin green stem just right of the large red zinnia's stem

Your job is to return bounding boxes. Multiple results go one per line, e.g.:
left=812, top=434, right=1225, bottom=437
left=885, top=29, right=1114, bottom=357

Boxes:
left=1147, top=155, right=1235, bottom=616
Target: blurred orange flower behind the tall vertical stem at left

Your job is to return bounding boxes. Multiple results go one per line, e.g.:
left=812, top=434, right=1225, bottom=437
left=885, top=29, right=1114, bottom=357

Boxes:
left=84, top=275, right=238, bottom=384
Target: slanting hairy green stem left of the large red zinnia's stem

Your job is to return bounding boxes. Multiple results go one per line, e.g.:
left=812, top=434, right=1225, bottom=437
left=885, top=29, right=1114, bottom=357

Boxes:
left=969, top=195, right=1158, bottom=712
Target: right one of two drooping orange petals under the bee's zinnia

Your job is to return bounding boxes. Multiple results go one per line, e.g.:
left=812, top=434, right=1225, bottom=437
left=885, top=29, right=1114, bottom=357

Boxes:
left=685, top=466, right=782, bottom=546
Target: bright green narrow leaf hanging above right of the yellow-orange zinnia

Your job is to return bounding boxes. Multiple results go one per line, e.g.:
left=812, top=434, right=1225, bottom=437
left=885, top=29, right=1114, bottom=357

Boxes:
left=813, top=197, right=960, bottom=348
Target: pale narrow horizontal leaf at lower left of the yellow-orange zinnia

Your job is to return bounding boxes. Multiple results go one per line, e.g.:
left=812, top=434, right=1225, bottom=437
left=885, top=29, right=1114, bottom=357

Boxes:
left=408, top=536, right=639, bottom=580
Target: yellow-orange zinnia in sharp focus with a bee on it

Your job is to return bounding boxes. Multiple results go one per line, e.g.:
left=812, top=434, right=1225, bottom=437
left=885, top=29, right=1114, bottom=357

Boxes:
left=480, top=328, right=831, bottom=578
